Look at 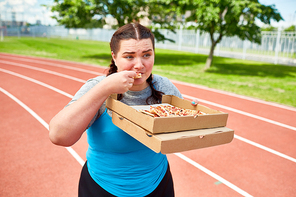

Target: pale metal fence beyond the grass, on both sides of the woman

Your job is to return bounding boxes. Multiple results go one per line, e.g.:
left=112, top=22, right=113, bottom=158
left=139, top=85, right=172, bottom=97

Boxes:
left=0, top=26, right=296, bottom=66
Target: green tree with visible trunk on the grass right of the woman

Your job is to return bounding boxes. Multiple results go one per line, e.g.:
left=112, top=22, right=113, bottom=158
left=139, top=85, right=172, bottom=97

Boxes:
left=182, top=0, right=282, bottom=69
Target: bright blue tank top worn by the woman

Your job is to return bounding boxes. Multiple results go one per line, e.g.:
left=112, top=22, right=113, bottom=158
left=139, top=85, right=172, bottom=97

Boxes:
left=86, top=110, right=168, bottom=197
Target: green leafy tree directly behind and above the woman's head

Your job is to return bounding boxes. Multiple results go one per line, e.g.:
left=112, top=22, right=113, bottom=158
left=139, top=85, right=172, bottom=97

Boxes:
left=51, top=0, right=180, bottom=41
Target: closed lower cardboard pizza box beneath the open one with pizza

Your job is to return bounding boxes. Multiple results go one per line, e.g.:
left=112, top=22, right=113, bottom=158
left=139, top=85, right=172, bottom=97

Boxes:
left=112, top=112, right=234, bottom=154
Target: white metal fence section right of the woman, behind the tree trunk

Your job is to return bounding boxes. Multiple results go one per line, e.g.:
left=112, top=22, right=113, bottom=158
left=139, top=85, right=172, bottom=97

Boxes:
left=157, top=29, right=296, bottom=65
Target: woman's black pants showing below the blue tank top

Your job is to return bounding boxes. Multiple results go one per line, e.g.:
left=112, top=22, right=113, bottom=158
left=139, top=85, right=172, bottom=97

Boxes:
left=78, top=163, right=175, bottom=197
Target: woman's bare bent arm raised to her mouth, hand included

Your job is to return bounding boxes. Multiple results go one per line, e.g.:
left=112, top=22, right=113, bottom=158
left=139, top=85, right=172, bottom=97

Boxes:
left=49, top=71, right=136, bottom=146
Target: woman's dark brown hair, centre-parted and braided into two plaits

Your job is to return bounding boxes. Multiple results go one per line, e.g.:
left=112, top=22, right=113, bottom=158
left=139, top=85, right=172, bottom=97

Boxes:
left=107, top=23, right=164, bottom=104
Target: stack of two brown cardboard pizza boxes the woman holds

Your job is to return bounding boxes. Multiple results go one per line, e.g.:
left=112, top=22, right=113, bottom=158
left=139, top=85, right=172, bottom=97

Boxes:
left=106, top=95, right=234, bottom=154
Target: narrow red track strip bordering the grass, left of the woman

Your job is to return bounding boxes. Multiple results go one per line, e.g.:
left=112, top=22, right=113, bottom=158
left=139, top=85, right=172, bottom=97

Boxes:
left=1, top=56, right=107, bottom=75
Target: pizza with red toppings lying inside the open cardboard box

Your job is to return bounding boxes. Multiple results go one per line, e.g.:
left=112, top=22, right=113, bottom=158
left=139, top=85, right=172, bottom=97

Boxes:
left=140, top=105, right=205, bottom=118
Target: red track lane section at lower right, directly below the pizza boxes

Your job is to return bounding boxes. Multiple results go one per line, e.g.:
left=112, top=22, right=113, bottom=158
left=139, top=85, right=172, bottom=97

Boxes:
left=182, top=139, right=296, bottom=196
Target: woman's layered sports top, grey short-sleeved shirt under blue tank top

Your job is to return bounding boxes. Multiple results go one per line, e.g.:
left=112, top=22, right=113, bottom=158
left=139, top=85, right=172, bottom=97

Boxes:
left=69, top=75, right=182, bottom=197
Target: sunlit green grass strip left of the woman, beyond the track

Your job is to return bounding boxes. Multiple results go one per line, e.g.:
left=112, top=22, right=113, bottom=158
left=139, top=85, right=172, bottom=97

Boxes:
left=0, top=37, right=110, bottom=65
